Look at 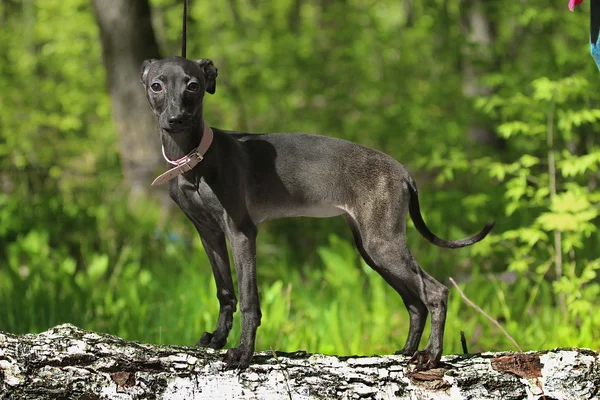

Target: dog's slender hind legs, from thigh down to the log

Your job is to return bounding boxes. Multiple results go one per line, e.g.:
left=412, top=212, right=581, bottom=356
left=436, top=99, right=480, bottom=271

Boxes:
left=346, top=182, right=448, bottom=369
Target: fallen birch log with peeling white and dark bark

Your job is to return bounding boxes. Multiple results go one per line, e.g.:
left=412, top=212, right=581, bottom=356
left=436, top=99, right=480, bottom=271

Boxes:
left=0, top=324, right=600, bottom=400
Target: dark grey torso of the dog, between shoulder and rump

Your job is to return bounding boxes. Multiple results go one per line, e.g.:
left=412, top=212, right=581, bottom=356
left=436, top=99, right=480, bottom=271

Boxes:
left=220, top=131, right=412, bottom=223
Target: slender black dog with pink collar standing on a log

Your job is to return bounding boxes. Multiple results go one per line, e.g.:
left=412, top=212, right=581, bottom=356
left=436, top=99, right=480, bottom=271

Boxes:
left=141, top=57, right=493, bottom=369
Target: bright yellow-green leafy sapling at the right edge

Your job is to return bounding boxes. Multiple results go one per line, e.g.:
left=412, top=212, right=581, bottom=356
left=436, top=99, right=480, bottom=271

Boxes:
left=479, top=76, right=600, bottom=340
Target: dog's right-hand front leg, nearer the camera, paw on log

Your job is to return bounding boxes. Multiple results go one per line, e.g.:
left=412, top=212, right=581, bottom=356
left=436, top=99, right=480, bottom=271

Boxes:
left=225, top=222, right=262, bottom=368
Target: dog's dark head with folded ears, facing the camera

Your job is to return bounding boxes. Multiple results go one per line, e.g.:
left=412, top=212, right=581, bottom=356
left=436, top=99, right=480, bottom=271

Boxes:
left=141, top=57, right=218, bottom=133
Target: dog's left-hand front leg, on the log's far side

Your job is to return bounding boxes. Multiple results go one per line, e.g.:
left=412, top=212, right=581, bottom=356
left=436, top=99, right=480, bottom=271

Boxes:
left=196, top=232, right=237, bottom=349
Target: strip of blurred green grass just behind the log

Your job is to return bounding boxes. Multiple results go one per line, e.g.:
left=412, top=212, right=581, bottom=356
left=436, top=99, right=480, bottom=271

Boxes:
left=0, top=225, right=600, bottom=355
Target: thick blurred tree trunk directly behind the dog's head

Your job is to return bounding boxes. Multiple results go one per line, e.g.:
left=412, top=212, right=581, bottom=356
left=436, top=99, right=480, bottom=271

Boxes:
left=94, top=0, right=165, bottom=200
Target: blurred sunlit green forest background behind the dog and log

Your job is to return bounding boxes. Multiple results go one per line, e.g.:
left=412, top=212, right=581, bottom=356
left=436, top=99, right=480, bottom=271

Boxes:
left=0, top=0, right=600, bottom=354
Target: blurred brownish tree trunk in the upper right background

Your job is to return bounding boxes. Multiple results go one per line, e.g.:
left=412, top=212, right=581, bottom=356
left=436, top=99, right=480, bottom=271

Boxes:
left=461, top=0, right=503, bottom=149
